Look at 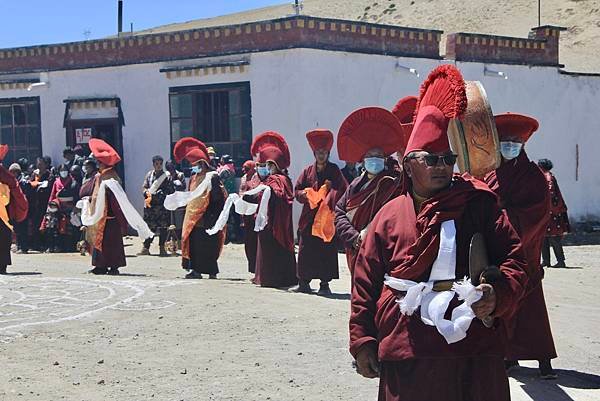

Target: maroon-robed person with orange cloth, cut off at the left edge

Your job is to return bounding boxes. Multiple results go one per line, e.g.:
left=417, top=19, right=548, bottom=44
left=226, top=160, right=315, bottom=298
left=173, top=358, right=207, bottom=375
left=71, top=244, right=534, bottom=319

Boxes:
left=0, top=145, right=28, bottom=274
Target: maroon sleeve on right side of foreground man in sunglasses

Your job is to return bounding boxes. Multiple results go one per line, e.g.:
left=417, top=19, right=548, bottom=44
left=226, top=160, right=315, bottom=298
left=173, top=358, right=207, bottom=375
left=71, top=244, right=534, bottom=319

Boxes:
left=483, top=198, right=527, bottom=317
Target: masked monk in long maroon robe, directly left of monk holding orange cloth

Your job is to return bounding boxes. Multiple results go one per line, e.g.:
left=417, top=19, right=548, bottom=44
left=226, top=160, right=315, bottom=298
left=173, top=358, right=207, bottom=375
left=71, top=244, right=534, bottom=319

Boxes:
left=244, top=131, right=298, bottom=288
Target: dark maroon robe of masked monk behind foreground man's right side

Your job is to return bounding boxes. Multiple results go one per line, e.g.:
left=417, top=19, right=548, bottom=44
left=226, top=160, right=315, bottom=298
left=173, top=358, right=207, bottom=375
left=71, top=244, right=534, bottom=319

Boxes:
left=485, top=151, right=556, bottom=360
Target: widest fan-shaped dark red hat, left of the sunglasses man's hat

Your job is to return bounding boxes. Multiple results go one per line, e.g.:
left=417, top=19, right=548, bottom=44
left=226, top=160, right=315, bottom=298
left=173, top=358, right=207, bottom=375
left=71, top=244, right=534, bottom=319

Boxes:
left=337, top=107, right=406, bottom=163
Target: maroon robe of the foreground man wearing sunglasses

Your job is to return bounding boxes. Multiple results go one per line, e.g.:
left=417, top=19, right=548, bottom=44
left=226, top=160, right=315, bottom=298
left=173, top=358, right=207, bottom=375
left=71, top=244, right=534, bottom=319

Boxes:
left=350, top=175, right=527, bottom=401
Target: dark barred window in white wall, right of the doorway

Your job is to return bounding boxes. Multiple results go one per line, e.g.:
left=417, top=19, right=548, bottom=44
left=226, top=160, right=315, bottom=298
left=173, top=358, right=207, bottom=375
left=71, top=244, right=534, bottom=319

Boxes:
left=169, top=82, right=252, bottom=166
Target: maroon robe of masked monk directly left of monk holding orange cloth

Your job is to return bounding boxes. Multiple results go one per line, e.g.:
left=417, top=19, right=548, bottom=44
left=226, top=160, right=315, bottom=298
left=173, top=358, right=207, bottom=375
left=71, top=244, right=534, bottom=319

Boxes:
left=255, top=174, right=298, bottom=288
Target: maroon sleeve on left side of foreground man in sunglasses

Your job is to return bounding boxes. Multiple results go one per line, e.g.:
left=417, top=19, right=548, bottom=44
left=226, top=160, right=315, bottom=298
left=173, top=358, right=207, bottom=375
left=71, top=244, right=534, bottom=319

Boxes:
left=350, top=213, right=389, bottom=357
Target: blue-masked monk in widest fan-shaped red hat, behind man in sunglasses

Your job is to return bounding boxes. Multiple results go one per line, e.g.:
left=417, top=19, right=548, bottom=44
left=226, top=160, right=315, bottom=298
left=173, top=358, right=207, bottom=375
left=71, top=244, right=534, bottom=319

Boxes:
left=335, top=107, right=408, bottom=280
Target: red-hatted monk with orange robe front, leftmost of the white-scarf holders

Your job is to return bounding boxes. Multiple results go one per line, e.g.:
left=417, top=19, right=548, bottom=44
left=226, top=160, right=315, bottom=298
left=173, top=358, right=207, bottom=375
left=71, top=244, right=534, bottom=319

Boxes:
left=86, top=139, right=129, bottom=275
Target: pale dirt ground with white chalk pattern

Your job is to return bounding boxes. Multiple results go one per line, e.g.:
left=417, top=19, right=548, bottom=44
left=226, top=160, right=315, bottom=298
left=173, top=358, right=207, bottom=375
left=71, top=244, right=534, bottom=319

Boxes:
left=0, top=239, right=600, bottom=401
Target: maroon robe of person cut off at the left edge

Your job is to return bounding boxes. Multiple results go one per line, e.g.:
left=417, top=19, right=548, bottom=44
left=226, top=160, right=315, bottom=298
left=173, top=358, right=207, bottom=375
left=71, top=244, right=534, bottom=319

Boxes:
left=0, top=165, right=29, bottom=267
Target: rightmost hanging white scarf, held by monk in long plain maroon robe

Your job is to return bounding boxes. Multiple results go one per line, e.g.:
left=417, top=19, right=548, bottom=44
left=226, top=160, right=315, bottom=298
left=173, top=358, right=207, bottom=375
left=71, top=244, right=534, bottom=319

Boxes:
left=206, top=184, right=271, bottom=235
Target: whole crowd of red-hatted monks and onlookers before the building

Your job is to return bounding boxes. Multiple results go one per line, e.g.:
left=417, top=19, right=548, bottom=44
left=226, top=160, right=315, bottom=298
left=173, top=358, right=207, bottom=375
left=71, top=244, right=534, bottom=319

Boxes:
left=0, top=65, right=569, bottom=401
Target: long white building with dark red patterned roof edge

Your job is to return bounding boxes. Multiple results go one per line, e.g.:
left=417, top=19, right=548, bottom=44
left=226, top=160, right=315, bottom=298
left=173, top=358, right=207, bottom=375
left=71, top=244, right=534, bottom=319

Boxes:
left=0, top=16, right=600, bottom=220
